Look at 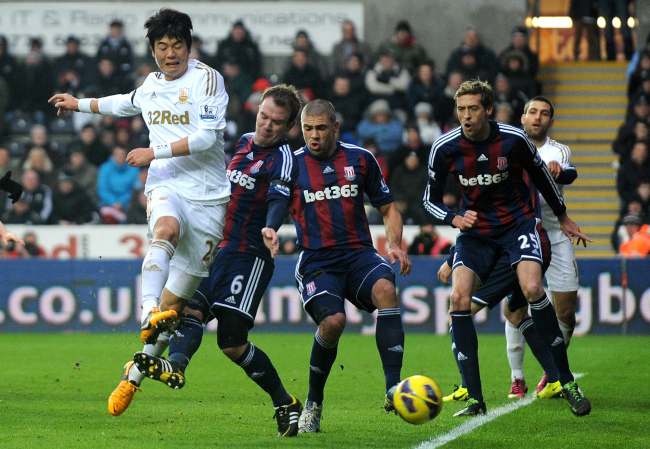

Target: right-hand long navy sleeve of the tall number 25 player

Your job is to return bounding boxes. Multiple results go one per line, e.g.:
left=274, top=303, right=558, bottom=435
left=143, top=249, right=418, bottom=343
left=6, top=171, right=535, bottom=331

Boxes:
left=515, top=136, right=566, bottom=216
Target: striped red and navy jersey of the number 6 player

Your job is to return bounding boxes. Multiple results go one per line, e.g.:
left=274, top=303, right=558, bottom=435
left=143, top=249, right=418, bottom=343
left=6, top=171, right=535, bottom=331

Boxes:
left=219, top=133, right=298, bottom=260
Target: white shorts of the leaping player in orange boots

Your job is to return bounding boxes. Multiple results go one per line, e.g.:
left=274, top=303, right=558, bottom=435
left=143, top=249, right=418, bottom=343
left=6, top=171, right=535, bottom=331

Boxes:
left=147, top=183, right=228, bottom=277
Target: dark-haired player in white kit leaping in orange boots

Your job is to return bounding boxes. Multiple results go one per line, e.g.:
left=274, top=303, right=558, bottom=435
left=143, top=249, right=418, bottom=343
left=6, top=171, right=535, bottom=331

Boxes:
left=49, top=8, right=230, bottom=415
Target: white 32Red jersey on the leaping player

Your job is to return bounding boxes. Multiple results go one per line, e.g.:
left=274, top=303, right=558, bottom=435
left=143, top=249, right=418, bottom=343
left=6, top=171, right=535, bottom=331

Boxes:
left=98, top=59, right=230, bottom=202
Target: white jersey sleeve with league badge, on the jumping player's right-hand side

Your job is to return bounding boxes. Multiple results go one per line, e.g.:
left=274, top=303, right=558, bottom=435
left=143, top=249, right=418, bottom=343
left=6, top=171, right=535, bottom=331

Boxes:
left=194, top=66, right=228, bottom=131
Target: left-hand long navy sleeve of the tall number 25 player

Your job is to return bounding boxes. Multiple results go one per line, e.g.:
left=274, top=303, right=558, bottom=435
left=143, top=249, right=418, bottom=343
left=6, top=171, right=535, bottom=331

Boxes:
left=422, top=142, right=456, bottom=225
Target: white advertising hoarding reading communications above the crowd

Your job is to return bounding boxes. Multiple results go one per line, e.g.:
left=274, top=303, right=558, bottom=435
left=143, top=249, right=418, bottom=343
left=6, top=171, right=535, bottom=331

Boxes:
left=0, top=2, right=363, bottom=56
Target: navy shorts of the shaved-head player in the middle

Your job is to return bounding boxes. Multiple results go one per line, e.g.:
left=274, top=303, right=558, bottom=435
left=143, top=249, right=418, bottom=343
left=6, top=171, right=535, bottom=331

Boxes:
left=296, top=248, right=395, bottom=319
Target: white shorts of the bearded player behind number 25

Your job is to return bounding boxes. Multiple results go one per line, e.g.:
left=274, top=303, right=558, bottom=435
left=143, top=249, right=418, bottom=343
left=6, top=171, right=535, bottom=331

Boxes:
left=546, top=230, right=579, bottom=292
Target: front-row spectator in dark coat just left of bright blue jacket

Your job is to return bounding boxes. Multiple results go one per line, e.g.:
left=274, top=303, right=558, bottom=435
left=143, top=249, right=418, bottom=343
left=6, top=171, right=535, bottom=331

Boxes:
left=48, top=171, right=99, bottom=225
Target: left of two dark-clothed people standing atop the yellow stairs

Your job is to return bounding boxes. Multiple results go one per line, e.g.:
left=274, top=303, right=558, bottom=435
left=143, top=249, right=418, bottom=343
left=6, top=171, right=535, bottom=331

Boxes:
left=569, top=0, right=601, bottom=61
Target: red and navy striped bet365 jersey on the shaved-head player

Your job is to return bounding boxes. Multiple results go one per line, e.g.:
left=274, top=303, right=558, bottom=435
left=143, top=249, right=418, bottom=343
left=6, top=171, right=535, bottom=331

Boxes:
left=291, top=142, right=393, bottom=249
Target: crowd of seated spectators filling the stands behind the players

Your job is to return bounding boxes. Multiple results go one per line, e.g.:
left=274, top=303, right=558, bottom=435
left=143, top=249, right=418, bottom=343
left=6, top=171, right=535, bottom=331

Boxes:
left=0, top=14, right=650, bottom=256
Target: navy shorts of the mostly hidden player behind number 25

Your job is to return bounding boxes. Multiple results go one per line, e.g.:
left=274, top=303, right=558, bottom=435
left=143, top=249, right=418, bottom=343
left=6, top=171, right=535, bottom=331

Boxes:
left=472, top=225, right=551, bottom=312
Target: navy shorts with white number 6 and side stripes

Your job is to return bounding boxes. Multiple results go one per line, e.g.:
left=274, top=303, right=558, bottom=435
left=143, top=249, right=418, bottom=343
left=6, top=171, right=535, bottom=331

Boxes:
left=190, top=248, right=275, bottom=327
